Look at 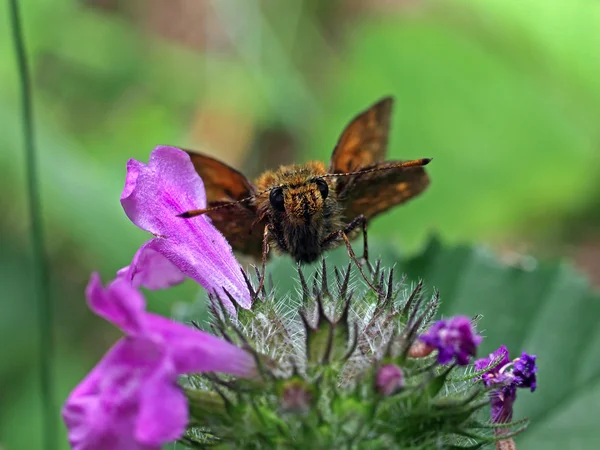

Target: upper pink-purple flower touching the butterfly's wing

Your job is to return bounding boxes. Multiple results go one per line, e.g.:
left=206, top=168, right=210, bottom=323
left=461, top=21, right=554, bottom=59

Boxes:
left=119, top=147, right=251, bottom=315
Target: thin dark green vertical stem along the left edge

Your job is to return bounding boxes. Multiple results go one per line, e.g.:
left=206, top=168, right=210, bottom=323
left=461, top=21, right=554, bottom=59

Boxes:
left=9, top=0, right=57, bottom=450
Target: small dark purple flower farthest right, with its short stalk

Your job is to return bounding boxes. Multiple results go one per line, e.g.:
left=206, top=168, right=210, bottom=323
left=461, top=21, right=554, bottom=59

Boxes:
left=475, top=345, right=537, bottom=423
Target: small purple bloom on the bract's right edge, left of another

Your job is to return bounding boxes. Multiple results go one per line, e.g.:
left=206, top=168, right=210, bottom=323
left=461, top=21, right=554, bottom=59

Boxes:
left=420, top=316, right=482, bottom=366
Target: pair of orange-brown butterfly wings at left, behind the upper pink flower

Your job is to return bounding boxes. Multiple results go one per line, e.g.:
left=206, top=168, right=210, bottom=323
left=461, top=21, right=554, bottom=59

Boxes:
left=186, top=150, right=265, bottom=258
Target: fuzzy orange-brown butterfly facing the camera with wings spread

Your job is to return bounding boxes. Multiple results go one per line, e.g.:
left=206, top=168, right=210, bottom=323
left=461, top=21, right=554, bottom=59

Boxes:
left=180, top=97, right=431, bottom=290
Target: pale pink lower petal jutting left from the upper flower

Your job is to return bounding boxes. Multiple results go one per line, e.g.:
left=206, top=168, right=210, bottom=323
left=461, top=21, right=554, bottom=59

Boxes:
left=117, top=240, right=185, bottom=290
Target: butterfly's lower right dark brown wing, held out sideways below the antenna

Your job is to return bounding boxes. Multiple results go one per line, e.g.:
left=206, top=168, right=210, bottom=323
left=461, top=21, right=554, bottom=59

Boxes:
left=338, top=161, right=429, bottom=222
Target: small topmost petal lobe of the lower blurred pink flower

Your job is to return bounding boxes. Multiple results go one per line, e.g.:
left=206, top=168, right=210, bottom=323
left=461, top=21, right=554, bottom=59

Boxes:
left=86, top=273, right=146, bottom=334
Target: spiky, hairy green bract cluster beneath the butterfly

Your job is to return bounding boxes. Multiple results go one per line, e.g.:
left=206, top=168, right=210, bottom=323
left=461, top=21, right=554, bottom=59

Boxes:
left=182, top=262, right=526, bottom=449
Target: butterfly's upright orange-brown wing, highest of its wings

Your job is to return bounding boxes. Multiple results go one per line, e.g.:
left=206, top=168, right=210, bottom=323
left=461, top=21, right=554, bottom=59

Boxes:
left=329, top=97, right=393, bottom=173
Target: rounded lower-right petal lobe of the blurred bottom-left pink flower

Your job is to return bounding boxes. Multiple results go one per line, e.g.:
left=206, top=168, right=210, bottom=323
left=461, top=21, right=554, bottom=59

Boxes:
left=135, top=361, right=188, bottom=445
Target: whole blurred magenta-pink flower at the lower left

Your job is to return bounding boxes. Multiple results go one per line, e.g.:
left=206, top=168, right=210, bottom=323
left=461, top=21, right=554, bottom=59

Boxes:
left=62, top=274, right=256, bottom=450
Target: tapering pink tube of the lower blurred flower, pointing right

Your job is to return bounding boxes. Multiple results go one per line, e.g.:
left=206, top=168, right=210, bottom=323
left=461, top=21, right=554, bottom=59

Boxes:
left=146, top=313, right=256, bottom=378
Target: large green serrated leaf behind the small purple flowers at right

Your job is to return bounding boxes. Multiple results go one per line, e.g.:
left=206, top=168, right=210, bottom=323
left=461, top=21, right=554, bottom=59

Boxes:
left=398, top=240, right=600, bottom=450
